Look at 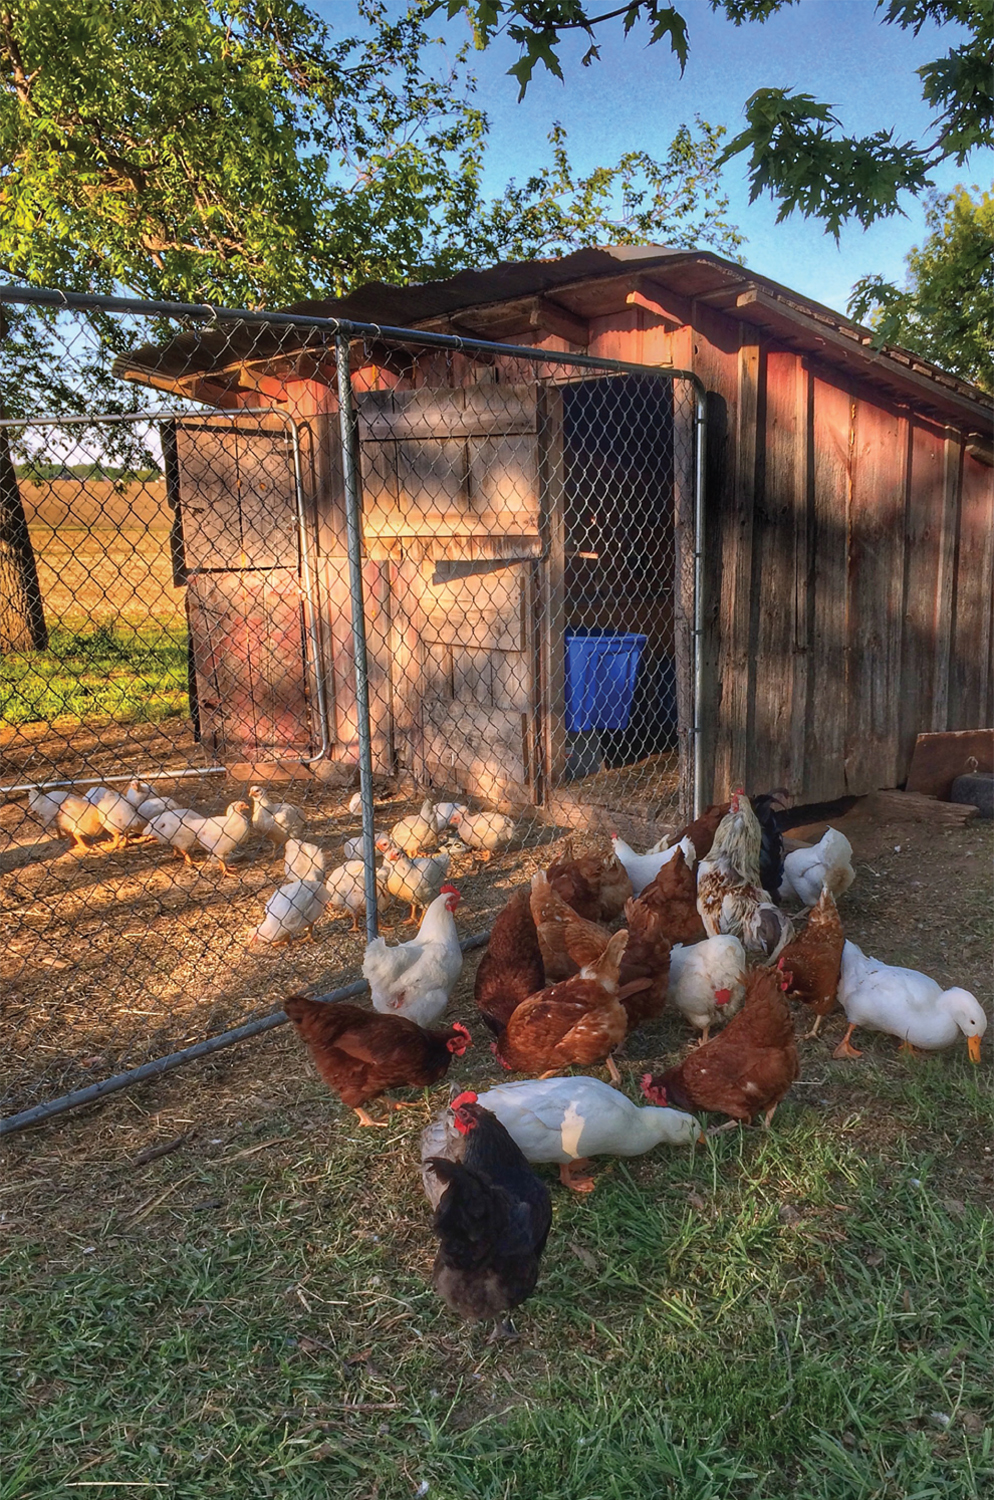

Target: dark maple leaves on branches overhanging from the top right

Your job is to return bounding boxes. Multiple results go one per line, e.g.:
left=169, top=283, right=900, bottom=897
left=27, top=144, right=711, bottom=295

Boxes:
left=433, top=0, right=994, bottom=237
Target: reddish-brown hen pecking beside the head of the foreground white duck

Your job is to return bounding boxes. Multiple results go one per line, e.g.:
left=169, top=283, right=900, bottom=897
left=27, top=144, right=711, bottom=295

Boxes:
left=642, top=969, right=801, bottom=1125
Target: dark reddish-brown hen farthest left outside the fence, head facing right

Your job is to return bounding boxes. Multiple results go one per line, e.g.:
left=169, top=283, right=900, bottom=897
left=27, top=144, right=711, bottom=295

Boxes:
left=283, top=995, right=472, bottom=1125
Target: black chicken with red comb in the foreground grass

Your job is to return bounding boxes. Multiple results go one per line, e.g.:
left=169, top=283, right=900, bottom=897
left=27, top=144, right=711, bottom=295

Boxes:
left=421, top=1094, right=552, bottom=1338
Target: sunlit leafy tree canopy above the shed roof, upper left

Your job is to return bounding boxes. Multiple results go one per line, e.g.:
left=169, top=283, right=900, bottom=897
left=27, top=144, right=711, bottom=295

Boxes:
left=0, top=0, right=741, bottom=306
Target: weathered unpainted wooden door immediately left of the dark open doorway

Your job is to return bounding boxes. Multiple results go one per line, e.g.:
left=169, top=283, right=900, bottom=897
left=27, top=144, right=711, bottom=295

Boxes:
left=357, top=384, right=549, bottom=806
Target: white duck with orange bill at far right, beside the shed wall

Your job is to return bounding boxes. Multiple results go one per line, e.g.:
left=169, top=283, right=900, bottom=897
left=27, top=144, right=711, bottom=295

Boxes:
left=832, top=942, right=987, bottom=1062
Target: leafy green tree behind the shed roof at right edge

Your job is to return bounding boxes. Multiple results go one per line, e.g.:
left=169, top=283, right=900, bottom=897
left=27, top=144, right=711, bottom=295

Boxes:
left=849, top=188, right=994, bottom=392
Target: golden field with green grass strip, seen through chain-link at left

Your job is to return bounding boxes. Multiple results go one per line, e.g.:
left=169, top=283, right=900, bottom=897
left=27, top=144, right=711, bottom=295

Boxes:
left=0, top=479, right=189, bottom=726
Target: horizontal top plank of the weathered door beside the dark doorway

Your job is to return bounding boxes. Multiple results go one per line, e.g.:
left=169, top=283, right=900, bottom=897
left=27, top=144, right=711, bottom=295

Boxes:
left=355, top=383, right=535, bottom=443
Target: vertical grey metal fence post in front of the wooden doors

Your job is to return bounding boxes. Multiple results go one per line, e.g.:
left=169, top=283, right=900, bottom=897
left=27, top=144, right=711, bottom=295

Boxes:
left=334, top=333, right=379, bottom=942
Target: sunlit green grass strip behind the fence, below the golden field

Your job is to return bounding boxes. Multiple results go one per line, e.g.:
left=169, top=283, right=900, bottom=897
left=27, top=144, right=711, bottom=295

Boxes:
left=0, top=621, right=189, bottom=725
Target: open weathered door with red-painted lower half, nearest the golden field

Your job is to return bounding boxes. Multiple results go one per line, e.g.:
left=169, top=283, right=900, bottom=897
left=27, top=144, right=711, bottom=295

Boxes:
left=165, top=417, right=312, bottom=759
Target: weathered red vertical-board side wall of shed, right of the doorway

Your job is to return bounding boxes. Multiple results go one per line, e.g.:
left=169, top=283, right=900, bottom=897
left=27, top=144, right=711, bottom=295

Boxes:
left=696, top=333, right=994, bottom=801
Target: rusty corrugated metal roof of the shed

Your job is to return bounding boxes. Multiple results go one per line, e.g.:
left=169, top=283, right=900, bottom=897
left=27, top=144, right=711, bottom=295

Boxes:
left=114, top=245, right=990, bottom=426
